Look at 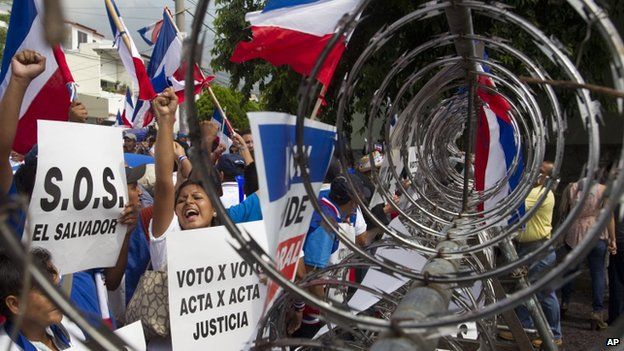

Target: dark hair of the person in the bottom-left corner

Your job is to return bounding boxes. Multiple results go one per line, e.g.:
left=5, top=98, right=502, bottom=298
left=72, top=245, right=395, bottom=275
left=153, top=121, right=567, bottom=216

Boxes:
left=0, top=248, right=58, bottom=319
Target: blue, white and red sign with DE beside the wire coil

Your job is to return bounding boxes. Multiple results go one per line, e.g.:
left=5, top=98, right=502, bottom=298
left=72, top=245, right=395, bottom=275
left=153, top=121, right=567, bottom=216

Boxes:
left=249, top=112, right=336, bottom=309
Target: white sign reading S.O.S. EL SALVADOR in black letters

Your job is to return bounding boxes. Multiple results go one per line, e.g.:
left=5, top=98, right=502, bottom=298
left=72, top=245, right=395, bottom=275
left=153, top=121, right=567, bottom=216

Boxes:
left=23, top=120, right=128, bottom=274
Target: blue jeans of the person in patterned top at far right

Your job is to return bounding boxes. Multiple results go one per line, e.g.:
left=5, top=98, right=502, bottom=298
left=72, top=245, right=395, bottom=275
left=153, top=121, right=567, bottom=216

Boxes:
left=561, top=240, right=607, bottom=312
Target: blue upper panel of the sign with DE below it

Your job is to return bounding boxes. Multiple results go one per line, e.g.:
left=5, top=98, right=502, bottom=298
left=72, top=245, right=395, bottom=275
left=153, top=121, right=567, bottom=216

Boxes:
left=258, top=124, right=336, bottom=202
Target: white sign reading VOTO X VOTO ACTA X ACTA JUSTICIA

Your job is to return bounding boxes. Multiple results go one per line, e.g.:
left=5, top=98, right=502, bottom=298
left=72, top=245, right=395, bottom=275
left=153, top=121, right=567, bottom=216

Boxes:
left=167, top=221, right=266, bottom=350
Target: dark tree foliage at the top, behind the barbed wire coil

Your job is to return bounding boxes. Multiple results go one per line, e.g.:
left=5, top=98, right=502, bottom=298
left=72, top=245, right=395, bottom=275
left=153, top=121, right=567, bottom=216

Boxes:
left=212, top=0, right=624, bottom=131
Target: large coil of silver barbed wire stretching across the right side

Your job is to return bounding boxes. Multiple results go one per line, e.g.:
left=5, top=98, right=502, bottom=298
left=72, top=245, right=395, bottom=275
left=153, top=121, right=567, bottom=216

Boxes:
left=189, top=0, right=624, bottom=349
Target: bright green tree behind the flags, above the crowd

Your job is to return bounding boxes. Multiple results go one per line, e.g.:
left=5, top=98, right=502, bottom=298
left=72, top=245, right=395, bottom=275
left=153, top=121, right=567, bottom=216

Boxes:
left=197, top=85, right=262, bottom=130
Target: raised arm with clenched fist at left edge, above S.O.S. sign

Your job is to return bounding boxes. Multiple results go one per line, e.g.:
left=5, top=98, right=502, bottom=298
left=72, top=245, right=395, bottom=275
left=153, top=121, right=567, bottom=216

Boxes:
left=0, top=50, right=45, bottom=194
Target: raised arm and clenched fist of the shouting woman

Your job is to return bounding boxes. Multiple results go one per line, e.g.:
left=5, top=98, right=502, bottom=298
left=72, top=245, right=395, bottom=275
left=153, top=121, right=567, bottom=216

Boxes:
left=152, top=88, right=178, bottom=238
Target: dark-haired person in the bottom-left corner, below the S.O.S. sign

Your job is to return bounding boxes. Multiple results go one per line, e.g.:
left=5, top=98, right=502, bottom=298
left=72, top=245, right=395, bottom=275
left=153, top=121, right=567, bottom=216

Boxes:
left=0, top=249, right=84, bottom=351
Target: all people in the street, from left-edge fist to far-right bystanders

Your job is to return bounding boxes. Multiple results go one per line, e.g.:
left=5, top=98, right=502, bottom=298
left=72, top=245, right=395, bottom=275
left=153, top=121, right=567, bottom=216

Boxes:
left=0, top=51, right=624, bottom=350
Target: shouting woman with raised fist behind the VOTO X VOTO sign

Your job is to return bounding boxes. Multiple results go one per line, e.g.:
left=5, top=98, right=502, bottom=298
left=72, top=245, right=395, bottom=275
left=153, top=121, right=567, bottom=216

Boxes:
left=150, top=88, right=215, bottom=270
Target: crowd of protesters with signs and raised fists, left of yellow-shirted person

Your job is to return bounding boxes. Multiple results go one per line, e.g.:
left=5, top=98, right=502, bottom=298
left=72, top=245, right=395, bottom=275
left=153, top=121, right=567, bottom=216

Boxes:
left=0, top=51, right=398, bottom=350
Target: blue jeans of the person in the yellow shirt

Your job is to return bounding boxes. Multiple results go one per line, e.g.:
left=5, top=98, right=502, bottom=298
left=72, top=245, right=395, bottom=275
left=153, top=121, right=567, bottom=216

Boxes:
left=516, top=242, right=561, bottom=339
